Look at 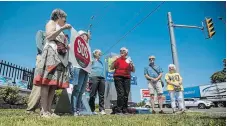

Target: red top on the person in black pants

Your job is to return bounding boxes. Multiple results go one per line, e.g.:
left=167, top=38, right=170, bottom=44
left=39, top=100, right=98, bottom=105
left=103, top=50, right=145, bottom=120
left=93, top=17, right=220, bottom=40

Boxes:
left=114, top=57, right=132, bottom=78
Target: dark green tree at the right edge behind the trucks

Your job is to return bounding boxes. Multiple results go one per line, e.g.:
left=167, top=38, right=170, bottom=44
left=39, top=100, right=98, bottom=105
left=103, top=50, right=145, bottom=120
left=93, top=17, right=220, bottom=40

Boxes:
left=210, top=59, right=226, bottom=83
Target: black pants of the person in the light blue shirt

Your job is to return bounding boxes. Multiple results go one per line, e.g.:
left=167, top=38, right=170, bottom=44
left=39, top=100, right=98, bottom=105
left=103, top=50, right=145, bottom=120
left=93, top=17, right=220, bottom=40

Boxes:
left=89, top=77, right=105, bottom=112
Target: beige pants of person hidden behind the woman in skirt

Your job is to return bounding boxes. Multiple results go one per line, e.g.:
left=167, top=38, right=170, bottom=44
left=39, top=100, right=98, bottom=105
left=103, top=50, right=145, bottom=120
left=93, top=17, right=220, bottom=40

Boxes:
left=27, top=85, right=41, bottom=111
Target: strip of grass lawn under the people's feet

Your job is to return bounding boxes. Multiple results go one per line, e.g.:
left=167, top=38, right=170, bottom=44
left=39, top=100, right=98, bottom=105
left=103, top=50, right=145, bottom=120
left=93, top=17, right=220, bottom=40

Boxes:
left=0, top=109, right=226, bottom=126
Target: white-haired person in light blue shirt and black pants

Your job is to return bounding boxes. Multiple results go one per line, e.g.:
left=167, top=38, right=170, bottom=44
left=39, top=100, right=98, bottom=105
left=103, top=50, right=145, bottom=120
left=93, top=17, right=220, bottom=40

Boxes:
left=89, top=49, right=106, bottom=115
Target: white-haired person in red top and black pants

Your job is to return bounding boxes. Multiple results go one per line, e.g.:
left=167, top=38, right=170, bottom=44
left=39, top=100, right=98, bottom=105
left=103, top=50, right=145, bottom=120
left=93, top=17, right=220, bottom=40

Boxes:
left=111, top=47, right=135, bottom=115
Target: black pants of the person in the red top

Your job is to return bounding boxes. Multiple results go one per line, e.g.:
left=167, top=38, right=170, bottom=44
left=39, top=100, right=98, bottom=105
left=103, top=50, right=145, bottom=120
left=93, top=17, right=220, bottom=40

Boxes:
left=114, top=77, right=131, bottom=113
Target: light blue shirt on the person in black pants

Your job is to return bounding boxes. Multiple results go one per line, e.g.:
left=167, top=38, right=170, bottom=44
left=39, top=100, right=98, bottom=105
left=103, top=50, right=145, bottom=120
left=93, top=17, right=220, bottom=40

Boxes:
left=90, top=59, right=104, bottom=78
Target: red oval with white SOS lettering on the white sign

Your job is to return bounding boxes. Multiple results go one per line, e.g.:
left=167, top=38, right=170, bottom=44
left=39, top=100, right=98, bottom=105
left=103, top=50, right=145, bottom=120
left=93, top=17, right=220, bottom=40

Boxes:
left=74, top=36, right=90, bottom=68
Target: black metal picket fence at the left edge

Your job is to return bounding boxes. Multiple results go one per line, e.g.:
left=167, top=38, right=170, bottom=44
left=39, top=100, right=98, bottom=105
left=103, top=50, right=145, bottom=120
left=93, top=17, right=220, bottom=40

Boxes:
left=0, top=60, right=35, bottom=89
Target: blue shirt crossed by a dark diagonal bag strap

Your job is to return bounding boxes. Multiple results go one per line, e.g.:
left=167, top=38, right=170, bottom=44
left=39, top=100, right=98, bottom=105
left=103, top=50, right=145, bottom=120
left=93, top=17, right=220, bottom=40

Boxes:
left=144, top=65, right=163, bottom=78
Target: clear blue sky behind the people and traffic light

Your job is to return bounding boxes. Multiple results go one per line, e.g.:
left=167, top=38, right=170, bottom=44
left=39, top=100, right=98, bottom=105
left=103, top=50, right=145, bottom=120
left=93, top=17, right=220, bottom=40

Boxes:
left=0, top=2, right=226, bottom=101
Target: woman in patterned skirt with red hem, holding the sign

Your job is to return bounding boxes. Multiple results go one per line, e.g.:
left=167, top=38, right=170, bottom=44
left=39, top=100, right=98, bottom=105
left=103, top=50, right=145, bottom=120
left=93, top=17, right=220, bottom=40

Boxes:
left=33, top=9, right=71, bottom=118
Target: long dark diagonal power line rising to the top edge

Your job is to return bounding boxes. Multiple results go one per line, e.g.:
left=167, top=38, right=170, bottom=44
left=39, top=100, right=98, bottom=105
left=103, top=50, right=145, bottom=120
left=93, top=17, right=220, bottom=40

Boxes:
left=103, top=1, right=165, bottom=55
